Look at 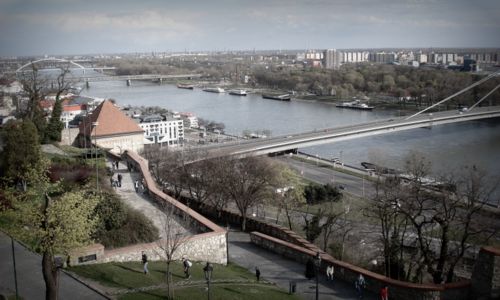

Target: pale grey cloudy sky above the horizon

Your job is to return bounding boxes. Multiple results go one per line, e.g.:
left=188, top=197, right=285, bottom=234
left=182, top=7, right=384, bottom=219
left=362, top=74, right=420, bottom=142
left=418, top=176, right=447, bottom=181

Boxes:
left=0, top=0, right=500, bottom=56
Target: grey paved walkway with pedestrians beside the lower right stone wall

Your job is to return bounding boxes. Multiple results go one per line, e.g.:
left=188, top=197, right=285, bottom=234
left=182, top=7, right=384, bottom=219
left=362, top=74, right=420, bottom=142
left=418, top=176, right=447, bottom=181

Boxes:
left=229, top=231, right=378, bottom=300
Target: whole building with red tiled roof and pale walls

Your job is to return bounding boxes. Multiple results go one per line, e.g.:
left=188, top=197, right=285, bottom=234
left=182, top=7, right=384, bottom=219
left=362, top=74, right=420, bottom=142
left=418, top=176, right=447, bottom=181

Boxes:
left=78, top=100, right=144, bottom=153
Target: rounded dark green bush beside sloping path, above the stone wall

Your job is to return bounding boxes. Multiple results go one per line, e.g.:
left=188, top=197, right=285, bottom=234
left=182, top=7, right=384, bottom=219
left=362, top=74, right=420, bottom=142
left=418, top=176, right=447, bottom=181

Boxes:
left=94, top=193, right=159, bottom=248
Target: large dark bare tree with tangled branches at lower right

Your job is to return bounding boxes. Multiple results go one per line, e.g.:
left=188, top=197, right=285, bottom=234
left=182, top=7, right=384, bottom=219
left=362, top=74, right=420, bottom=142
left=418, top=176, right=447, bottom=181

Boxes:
left=371, top=154, right=497, bottom=283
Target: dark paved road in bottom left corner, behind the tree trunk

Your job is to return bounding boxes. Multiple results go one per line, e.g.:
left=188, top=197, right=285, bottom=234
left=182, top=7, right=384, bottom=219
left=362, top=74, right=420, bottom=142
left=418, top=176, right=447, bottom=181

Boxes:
left=0, top=232, right=107, bottom=300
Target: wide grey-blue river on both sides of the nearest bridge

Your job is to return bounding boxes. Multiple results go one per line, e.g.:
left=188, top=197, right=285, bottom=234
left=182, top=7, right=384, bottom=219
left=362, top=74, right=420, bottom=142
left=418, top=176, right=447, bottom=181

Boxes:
left=82, top=81, right=500, bottom=200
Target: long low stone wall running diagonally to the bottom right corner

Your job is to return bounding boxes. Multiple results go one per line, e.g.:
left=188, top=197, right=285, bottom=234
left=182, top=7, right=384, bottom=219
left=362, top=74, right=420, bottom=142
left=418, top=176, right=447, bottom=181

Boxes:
left=250, top=232, right=470, bottom=300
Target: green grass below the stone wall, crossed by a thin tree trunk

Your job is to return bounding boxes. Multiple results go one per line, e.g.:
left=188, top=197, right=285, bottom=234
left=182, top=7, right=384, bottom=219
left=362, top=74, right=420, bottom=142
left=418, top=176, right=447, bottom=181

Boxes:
left=68, top=261, right=299, bottom=300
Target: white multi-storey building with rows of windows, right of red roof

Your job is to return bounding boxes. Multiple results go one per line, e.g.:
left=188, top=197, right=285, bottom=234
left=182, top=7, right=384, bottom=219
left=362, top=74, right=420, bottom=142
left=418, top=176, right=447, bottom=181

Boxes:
left=139, top=115, right=184, bottom=146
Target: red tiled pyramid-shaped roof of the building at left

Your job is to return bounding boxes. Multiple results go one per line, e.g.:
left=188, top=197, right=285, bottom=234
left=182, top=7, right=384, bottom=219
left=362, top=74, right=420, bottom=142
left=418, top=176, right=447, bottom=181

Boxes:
left=80, top=100, right=144, bottom=137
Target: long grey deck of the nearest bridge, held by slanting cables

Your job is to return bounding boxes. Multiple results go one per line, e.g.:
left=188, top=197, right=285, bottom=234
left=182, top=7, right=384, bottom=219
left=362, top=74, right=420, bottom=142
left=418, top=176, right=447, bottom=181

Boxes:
left=195, top=106, right=500, bottom=158
